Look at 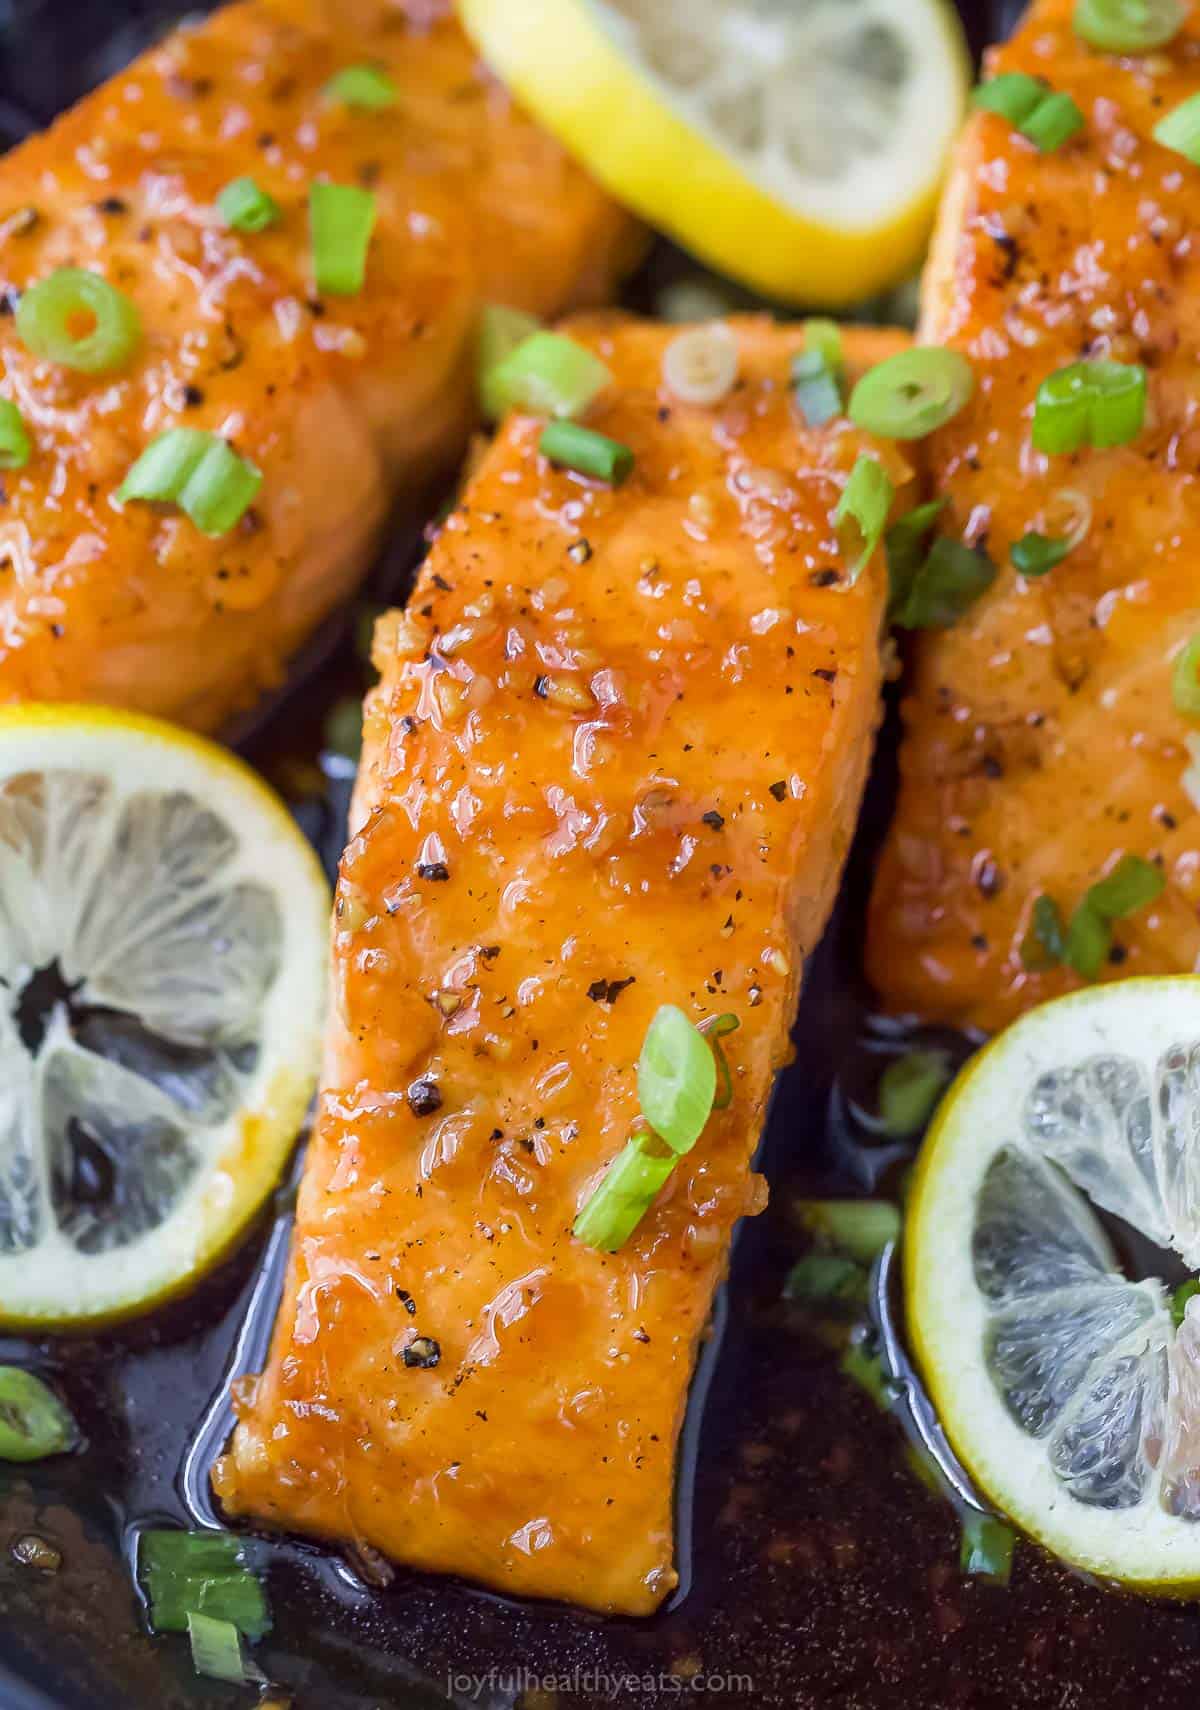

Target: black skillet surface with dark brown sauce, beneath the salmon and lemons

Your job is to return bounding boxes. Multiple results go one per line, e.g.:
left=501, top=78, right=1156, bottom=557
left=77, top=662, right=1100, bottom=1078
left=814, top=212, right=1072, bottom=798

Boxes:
left=0, top=0, right=1200, bottom=1710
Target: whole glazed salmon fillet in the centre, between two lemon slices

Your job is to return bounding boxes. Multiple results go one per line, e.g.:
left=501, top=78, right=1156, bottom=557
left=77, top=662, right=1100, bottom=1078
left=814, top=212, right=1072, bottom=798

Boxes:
left=215, top=316, right=913, bottom=1614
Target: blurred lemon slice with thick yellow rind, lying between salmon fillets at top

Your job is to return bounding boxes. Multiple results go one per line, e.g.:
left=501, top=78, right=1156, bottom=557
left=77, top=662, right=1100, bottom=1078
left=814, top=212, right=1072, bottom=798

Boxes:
left=458, top=0, right=971, bottom=304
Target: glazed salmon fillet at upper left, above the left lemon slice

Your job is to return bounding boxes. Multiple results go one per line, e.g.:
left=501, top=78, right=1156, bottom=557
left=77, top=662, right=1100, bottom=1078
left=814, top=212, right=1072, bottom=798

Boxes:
left=0, top=0, right=638, bottom=728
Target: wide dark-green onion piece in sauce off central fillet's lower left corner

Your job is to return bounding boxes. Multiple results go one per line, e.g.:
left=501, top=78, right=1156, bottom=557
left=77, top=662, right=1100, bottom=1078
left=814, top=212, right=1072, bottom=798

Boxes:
left=137, top=1530, right=270, bottom=1642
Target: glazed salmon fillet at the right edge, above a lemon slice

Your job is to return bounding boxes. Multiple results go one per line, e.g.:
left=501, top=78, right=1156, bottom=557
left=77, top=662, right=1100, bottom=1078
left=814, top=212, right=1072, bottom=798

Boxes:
left=868, top=0, right=1200, bottom=1029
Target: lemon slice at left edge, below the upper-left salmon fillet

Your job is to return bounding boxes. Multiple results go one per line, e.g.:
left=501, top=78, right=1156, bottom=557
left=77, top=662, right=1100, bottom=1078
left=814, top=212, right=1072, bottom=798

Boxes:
left=0, top=706, right=330, bottom=1325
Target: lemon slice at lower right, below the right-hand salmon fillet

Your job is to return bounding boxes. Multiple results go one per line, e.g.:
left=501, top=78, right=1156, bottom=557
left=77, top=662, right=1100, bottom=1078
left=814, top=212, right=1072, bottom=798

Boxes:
left=904, top=976, right=1200, bottom=1594
